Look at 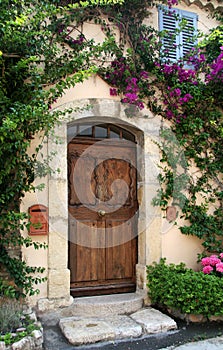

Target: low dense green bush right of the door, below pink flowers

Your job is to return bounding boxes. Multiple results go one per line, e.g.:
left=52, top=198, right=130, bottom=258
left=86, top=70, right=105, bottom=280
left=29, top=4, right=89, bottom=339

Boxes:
left=147, top=259, right=223, bottom=317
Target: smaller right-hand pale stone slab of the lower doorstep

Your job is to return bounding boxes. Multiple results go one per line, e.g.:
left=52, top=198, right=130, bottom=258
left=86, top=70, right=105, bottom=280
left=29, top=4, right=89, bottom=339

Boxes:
left=130, top=307, right=177, bottom=334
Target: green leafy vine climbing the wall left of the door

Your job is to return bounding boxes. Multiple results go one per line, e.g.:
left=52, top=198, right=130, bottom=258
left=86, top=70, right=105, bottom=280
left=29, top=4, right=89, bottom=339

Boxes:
left=0, top=0, right=122, bottom=298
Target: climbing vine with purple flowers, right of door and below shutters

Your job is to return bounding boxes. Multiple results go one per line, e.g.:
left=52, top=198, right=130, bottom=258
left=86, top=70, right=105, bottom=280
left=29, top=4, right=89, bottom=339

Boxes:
left=98, top=1, right=223, bottom=254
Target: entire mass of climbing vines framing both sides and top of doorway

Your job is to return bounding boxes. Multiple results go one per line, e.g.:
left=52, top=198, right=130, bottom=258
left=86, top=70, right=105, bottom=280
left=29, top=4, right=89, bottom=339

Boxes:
left=0, top=0, right=223, bottom=297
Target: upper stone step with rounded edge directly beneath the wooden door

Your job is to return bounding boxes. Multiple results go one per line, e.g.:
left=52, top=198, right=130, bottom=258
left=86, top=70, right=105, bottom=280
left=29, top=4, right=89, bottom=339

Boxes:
left=61, top=293, right=143, bottom=317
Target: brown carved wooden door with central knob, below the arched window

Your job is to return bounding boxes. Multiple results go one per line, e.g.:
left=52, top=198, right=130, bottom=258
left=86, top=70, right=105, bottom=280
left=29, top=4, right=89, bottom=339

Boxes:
left=68, top=138, right=137, bottom=295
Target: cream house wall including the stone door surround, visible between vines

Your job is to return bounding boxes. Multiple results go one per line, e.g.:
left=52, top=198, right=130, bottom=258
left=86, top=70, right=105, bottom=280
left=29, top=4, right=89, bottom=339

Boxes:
left=21, top=4, right=220, bottom=308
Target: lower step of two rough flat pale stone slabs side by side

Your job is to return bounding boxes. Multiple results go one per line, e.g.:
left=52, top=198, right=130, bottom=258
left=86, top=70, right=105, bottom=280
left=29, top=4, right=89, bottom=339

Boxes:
left=59, top=307, right=177, bottom=346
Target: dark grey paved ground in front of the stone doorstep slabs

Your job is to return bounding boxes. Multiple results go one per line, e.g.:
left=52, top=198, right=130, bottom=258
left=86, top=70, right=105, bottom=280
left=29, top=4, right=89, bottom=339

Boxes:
left=40, top=324, right=223, bottom=350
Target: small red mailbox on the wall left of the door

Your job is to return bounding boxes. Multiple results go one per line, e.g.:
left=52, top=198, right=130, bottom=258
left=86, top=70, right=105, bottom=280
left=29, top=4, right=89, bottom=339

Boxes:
left=29, top=204, right=49, bottom=235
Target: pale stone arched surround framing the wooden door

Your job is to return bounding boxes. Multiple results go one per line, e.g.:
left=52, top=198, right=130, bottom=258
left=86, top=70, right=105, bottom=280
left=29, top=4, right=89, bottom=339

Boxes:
left=44, top=99, right=161, bottom=305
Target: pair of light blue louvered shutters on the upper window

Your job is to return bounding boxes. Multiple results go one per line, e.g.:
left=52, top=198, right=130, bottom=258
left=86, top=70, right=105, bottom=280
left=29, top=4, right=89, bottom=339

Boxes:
left=159, top=7, right=197, bottom=62
